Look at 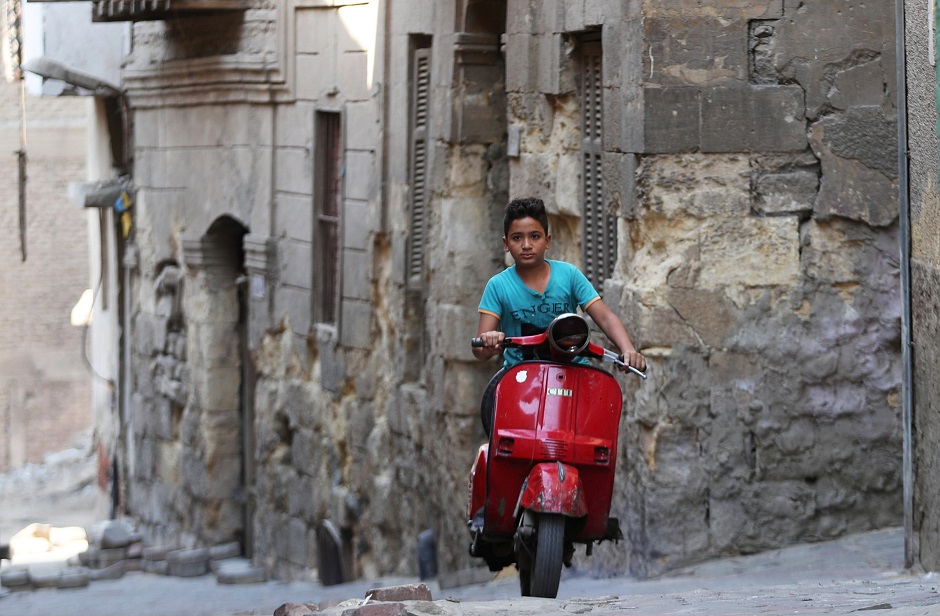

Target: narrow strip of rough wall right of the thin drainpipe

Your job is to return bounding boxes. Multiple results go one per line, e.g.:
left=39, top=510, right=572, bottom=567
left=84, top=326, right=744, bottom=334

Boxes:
left=904, top=2, right=940, bottom=571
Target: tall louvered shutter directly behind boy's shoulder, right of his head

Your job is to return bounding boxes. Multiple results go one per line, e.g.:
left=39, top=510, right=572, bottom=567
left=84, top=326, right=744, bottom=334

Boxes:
left=581, top=40, right=617, bottom=290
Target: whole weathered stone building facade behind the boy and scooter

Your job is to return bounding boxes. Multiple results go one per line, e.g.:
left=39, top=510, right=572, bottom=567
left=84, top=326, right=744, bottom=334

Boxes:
left=68, top=0, right=902, bottom=578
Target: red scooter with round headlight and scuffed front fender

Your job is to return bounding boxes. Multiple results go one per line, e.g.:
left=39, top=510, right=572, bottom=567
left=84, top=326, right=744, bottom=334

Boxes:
left=467, top=314, right=646, bottom=598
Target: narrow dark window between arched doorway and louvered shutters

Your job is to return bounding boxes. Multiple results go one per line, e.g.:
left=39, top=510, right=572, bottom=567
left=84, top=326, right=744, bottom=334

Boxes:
left=313, top=111, right=343, bottom=323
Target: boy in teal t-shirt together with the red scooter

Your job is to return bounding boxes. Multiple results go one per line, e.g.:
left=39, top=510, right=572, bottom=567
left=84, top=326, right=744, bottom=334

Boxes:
left=467, top=198, right=646, bottom=597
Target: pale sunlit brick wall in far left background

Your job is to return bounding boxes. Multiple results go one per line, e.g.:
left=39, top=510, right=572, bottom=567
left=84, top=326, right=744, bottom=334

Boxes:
left=0, top=83, right=92, bottom=472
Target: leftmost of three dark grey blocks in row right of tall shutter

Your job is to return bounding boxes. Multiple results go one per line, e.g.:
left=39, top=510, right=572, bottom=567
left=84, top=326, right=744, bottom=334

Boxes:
left=644, top=87, right=702, bottom=154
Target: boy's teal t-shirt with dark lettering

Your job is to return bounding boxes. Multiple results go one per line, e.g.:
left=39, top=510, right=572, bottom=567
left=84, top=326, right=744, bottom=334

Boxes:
left=479, top=260, right=600, bottom=368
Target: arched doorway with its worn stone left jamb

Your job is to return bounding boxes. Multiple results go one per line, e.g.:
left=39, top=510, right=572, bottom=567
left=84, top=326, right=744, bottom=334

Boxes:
left=184, top=216, right=255, bottom=556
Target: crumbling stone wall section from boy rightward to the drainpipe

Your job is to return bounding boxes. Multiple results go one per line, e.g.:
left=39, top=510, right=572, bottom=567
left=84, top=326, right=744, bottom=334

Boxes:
left=507, top=2, right=902, bottom=576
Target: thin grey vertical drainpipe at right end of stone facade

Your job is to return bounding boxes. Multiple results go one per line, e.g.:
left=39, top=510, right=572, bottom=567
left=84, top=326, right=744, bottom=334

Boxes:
left=894, top=0, right=919, bottom=568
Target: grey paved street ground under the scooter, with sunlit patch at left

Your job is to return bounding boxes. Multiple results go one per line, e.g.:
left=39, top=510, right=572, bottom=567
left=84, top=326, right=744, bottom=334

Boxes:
left=0, top=442, right=940, bottom=616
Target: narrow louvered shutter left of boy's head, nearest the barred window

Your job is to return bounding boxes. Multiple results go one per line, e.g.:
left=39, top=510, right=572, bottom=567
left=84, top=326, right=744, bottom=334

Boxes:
left=408, top=48, right=431, bottom=284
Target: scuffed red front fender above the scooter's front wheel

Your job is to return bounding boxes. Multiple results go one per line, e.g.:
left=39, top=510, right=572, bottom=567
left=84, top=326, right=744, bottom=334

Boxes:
left=516, top=462, right=587, bottom=518
